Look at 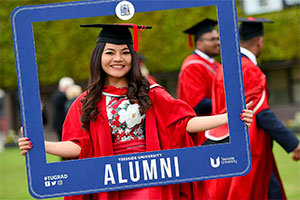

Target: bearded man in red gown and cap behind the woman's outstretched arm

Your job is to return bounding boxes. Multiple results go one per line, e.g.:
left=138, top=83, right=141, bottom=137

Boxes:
left=177, top=19, right=220, bottom=145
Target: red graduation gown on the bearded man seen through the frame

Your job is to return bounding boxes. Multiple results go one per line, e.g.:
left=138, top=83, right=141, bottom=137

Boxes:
left=177, top=54, right=220, bottom=145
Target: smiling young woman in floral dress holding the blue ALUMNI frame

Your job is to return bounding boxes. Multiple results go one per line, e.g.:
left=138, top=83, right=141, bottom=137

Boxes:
left=19, top=24, right=253, bottom=200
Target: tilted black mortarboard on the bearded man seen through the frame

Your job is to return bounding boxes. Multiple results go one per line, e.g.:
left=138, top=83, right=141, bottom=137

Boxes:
left=183, top=18, right=218, bottom=48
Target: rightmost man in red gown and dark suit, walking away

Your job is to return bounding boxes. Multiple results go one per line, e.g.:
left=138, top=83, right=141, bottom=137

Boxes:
left=207, top=17, right=300, bottom=200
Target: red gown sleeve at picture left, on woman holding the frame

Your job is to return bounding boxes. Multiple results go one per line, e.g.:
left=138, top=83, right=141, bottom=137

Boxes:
left=62, top=96, right=93, bottom=159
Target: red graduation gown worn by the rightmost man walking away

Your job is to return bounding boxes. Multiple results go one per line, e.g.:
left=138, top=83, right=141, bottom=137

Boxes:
left=207, top=57, right=286, bottom=200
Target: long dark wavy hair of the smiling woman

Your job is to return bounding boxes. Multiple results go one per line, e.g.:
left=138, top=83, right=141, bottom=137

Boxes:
left=80, top=43, right=152, bottom=130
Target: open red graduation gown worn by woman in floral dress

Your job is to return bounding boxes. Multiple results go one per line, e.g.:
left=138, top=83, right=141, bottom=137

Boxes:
left=63, top=84, right=208, bottom=200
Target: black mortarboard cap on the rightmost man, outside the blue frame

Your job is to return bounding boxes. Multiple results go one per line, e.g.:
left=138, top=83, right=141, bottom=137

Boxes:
left=238, top=17, right=273, bottom=40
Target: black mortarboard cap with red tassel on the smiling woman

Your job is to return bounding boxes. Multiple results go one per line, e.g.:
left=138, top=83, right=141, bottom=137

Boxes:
left=80, top=24, right=152, bottom=51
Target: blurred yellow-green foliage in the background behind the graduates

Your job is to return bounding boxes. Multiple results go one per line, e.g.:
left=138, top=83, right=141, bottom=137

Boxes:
left=0, top=0, right=300, bottom=89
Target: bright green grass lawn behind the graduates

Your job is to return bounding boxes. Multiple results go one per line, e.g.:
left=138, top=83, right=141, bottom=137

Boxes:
left=0, top=143, right=300, bottom=200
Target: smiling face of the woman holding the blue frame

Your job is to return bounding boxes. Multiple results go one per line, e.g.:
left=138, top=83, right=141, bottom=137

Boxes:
left=101, top=43, right=132, bottom=87
